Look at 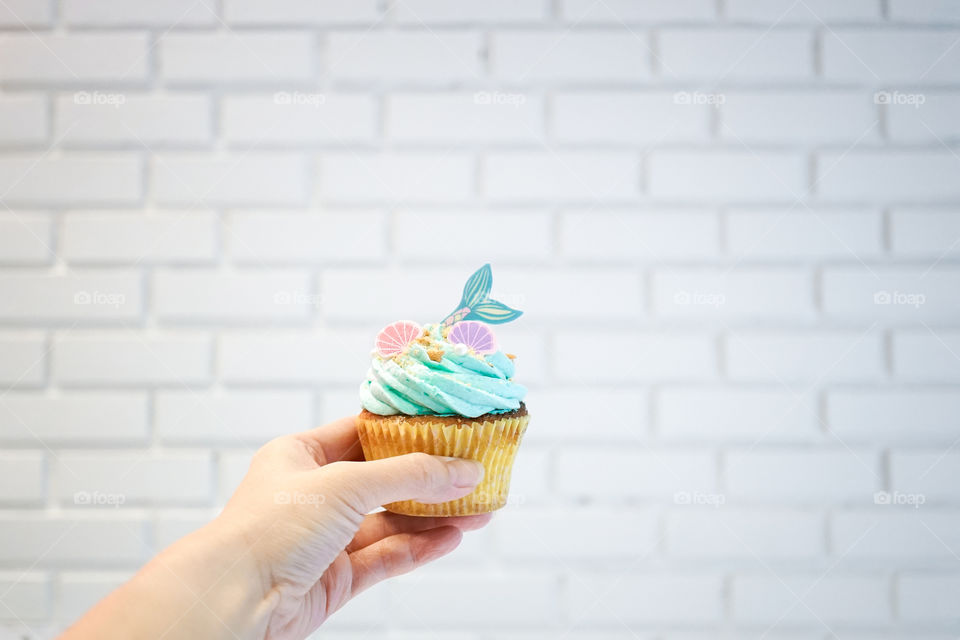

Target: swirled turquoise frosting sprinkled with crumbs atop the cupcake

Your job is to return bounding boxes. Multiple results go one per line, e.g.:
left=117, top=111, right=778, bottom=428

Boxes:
left=360, top=324, right=527, bottom=418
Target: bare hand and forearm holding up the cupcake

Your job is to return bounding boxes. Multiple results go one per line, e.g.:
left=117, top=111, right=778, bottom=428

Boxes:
left=61, top=417, right=490, bottom=640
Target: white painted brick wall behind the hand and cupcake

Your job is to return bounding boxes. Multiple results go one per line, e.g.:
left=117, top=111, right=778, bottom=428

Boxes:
left=0, top=0, right=960, bottom=640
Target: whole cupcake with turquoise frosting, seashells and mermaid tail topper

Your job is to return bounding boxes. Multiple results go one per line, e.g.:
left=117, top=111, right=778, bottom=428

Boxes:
left=357, top=264, right=530, bottom=516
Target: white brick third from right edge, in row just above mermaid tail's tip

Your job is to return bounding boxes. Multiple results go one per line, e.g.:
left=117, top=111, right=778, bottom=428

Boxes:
left=560, top=209, right=720, bottom=262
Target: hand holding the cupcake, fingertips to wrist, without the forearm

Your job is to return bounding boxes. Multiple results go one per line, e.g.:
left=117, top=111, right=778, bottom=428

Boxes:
left=218, top=417, right=491, bottom=639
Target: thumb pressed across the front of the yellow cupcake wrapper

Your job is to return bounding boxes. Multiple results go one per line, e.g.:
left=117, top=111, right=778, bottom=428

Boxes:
left=321, top=453, right=483, bottom=513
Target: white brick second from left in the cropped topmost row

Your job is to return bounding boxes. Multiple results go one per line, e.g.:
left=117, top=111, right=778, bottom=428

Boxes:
left=60, top=0, right=219, bottom=29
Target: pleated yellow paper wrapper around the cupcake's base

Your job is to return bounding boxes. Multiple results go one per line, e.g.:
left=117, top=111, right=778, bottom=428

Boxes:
left=357, top=414, right=530, bottom=516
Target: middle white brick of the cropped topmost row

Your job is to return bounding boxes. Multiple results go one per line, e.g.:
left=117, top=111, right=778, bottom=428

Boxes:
left=393, top=0, right=550, bottom=25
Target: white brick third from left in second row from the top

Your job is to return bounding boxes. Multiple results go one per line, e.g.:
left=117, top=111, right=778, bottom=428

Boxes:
left=324, top=31, right=481, bottom=84
